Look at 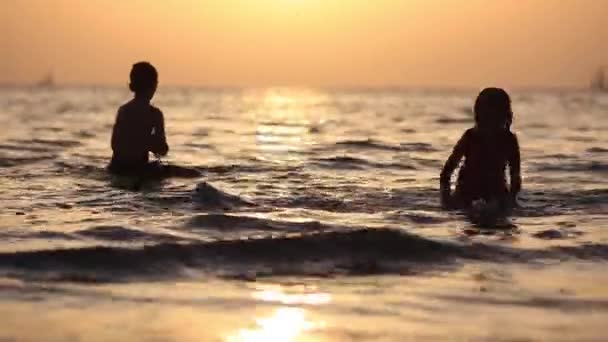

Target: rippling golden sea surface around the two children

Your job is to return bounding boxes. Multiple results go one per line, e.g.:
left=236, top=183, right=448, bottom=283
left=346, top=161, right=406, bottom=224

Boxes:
left=0, top=86, right=608, bottom=341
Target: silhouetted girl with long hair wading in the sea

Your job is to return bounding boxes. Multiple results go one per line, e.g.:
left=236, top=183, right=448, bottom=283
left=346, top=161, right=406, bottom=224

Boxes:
left=440, top=88, right=521, bottom=209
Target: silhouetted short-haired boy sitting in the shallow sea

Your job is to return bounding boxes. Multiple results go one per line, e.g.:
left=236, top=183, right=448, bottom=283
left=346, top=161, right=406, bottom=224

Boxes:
left=108, top=62, right=169, bottom=177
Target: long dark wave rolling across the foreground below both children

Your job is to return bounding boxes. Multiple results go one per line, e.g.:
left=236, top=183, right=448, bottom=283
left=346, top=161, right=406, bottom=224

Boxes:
left=0, top=229, right=608, bottom=282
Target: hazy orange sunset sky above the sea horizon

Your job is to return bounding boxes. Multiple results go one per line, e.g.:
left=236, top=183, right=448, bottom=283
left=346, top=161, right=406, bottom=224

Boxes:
left=0, top=0, right=608, bottom=87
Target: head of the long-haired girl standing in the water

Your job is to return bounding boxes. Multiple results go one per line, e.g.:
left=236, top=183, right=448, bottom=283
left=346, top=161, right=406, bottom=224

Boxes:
left=474, top=88, right=513, bottom=130
